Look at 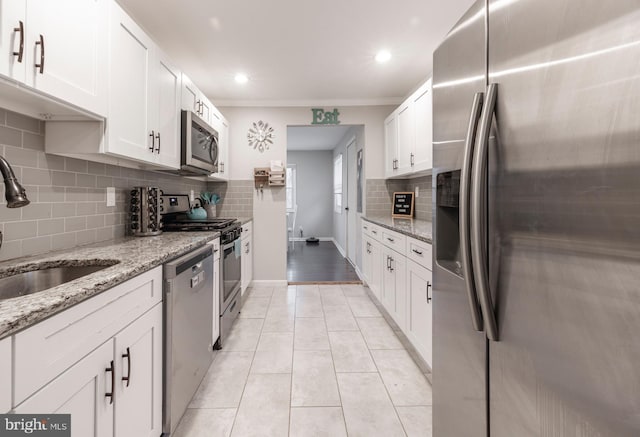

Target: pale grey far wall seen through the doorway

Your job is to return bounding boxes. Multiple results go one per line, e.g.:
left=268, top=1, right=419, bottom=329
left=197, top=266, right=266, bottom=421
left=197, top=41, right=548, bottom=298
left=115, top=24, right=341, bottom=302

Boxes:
left=287, top=150, right=333, bottom=238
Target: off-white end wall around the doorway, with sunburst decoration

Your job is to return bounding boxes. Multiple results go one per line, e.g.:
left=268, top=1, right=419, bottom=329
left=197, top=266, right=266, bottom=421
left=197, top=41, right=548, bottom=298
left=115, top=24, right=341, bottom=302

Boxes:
left=219, top=106, right=395, bottom=281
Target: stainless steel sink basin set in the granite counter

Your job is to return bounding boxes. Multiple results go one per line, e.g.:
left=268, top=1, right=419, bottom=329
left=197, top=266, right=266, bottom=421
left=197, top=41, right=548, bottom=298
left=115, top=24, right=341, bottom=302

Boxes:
left=0, top=260, right=119, bottom=300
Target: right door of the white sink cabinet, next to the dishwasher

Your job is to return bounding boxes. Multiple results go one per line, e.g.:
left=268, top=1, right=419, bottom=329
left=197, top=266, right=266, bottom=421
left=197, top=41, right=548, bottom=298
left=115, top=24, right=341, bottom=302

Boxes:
left=115, top=304, right=162, bottom=437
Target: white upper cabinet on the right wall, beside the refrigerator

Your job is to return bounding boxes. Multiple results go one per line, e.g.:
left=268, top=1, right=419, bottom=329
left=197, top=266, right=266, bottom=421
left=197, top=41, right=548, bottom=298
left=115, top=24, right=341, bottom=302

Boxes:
left=385, top=79, right=433, bottom=178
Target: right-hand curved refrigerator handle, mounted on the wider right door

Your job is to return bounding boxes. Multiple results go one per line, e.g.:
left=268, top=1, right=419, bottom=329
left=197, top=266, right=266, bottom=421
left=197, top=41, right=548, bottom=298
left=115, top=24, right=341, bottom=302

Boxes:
left=470, top=83, right=498, bottom=341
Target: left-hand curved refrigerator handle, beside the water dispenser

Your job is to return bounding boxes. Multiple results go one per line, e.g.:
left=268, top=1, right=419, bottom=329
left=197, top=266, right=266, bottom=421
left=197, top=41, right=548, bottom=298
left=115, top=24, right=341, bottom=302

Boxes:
left=460, top=93, right=484, bottom=332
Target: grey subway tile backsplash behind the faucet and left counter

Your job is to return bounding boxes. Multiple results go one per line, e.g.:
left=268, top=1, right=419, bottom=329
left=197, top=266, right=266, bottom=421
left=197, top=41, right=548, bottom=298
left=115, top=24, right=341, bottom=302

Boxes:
left=0, top=108, right=254, bottom=260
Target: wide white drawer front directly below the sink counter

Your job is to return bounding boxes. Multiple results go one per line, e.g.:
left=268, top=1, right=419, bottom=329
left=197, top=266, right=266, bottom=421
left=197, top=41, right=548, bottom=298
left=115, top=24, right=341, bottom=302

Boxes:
left=14, top=266, right=162, bottom=405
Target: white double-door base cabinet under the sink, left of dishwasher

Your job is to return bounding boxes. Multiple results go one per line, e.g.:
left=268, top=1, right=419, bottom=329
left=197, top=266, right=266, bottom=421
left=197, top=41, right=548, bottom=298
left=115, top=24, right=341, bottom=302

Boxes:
left=11, top=267, right=163, bottom=437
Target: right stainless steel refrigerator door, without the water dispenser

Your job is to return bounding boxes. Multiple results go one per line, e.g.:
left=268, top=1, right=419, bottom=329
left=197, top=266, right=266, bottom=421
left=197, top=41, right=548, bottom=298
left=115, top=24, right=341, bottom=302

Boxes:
left=488, top=0, right=640, bottom=437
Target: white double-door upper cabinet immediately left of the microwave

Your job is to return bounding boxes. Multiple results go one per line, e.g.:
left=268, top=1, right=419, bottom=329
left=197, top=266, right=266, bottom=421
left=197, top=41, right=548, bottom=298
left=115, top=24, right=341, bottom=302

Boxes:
left=105, top=2, right=181, bottom=168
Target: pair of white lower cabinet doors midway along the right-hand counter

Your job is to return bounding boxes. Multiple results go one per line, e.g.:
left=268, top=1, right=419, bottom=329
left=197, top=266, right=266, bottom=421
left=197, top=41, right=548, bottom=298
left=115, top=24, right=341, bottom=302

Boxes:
left=382, top=247, right=407, bottom=331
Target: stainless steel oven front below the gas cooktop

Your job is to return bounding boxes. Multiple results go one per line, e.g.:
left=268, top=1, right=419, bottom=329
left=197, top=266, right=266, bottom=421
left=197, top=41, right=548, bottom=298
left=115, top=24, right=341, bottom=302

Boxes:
left=219, top=222, right=242, bottom=347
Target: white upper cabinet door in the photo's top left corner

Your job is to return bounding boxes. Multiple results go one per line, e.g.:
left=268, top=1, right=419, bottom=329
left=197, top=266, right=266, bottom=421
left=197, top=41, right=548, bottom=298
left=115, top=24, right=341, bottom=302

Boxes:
left=0, top=0, right=27, bottom=82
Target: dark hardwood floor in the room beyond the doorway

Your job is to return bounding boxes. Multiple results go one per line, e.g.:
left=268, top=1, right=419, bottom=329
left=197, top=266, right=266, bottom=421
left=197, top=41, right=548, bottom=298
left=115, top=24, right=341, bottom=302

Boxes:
left=287, top=241, right=360, bottom=283
